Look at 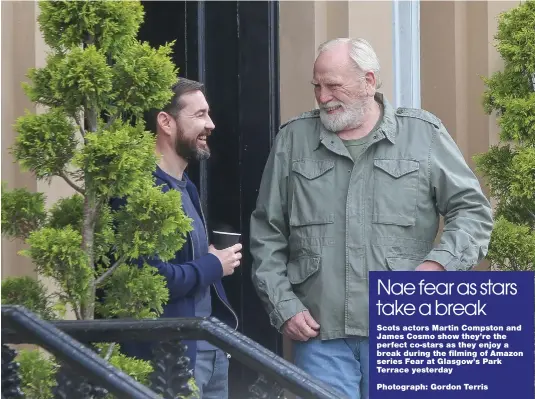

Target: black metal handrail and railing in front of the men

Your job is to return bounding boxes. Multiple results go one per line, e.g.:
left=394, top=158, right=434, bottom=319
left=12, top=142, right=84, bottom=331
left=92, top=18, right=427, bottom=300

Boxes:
left=2, top=306, right=341, bottom=399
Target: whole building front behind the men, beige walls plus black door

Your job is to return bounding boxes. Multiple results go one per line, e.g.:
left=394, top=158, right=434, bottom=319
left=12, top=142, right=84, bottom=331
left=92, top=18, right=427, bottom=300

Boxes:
left=1, top=1, right=516, bottom=396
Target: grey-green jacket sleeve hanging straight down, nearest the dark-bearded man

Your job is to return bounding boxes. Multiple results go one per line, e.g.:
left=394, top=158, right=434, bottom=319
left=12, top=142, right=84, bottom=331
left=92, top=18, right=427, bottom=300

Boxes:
left=250, top=130, right=306, bottom=331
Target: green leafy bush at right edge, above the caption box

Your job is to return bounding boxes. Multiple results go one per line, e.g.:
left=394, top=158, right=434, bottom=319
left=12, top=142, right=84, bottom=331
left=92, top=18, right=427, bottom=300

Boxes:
left=475, top=1, right=535, bottom=271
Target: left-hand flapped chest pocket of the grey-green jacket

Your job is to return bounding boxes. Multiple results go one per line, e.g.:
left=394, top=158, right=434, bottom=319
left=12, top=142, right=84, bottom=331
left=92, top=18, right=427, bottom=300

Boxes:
left=290, top=159, right=334, bottom=228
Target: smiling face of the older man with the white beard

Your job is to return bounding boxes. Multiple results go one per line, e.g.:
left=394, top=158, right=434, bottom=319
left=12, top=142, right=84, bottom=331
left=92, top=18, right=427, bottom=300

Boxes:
left=312, top=45, right=373, bottom=132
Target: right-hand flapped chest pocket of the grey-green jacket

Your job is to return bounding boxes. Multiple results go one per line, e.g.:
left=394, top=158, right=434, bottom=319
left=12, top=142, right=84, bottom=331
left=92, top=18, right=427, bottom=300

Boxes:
left=373, top=159, right=420, bottom=226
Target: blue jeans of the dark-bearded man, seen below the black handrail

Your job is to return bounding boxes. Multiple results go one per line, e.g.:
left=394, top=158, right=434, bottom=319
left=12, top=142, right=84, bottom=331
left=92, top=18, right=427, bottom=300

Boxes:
left=195, top=349, right=229, bottom=399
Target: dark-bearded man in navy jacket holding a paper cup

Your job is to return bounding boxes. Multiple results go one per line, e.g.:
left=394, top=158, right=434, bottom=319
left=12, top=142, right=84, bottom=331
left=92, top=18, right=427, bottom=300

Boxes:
left=113, top=78, right=242, bottom=399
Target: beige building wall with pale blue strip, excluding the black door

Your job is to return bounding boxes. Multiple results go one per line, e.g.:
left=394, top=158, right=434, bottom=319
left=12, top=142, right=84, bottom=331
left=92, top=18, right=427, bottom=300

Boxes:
left=1, top=1, right=516, bottom=275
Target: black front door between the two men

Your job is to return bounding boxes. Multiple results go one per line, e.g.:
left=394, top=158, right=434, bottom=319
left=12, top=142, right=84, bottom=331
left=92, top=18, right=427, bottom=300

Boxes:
left=139, top=1, right=282, bottom=398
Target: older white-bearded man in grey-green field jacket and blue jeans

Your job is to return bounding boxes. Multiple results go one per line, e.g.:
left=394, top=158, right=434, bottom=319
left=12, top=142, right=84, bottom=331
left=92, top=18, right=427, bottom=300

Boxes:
left=251, top=39, right=493, bottom=399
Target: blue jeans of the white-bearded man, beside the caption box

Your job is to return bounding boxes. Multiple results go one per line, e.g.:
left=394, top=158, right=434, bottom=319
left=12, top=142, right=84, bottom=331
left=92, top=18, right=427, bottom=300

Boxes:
left=293, top=337, right=370, bottom=399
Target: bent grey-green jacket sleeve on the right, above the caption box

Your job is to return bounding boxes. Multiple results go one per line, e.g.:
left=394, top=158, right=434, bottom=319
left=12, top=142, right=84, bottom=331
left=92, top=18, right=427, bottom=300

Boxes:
left=425, top=124, right=493, bottom=271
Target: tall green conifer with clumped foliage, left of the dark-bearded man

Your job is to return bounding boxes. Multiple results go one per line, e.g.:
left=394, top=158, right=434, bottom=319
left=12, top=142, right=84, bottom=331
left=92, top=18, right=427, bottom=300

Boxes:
left=2, top=1, right=198, bottom=398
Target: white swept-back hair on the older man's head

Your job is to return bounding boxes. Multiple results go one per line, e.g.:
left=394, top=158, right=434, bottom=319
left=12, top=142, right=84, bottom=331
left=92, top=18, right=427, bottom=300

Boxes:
left=318, top=37, right=382, bottom=89
